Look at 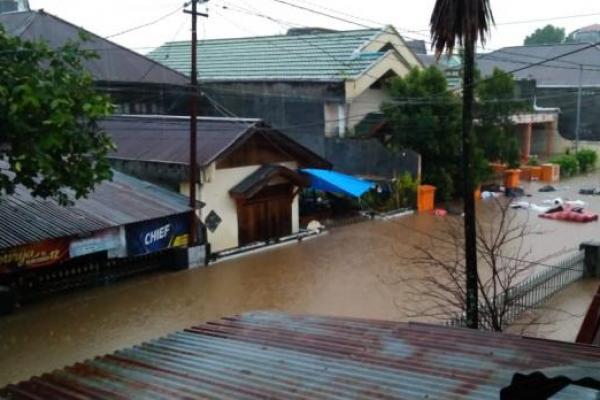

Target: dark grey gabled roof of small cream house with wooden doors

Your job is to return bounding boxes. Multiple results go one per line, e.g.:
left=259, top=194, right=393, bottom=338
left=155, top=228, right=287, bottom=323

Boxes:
left=99, top=115, right=331, bottom=168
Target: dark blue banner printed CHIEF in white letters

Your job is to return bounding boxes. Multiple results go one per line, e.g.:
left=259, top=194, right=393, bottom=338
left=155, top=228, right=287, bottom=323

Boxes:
left=125, top=214, right=190, bottom=256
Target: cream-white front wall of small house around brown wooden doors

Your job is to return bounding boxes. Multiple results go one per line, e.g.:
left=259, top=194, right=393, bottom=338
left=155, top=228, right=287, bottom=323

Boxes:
left=180, top=162, right=300, bottom=251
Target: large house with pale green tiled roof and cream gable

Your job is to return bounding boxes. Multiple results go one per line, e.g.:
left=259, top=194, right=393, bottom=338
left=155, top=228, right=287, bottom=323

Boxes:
left=148, top=26, right=422, bottom=177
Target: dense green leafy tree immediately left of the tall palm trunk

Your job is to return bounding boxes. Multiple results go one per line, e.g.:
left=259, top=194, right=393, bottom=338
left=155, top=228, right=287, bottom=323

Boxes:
left=382, top=67, right=460, bottom=200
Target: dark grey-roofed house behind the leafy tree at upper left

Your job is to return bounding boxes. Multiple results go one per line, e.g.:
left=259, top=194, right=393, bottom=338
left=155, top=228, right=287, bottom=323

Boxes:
left=0, top=4, right=189, bottom=114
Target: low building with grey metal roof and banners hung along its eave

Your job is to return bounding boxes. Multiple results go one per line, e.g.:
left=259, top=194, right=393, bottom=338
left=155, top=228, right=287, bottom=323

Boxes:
left=0, top=161, right=191, bottom=275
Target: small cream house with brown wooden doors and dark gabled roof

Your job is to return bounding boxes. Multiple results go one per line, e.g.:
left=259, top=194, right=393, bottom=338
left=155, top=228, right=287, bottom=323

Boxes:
left=100, top=116, right=331, bottom=252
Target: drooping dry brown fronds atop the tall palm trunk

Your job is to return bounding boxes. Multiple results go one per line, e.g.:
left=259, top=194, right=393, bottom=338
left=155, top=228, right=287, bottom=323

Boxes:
left=430, top=0, right=494, bottom=56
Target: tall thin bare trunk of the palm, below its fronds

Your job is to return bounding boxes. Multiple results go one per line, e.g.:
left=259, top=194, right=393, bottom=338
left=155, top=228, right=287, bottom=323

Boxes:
left=462, top=38, right=479, bottom=329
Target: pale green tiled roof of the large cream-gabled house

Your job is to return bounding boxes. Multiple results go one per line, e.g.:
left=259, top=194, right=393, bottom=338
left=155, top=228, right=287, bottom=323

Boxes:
left=148, top=29, right=394, bottom=81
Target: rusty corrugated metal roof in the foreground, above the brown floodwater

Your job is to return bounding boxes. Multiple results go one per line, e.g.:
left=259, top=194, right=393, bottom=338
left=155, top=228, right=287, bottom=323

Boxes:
left=0, top=313, right=600, bottom=400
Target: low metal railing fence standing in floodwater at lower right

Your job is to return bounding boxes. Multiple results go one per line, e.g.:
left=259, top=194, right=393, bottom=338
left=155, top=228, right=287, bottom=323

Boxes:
left=445, top=251, right=585, bottom=330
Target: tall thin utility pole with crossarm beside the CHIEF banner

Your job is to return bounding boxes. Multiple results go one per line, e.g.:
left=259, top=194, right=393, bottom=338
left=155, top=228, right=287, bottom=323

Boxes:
left=183, top=0, right=208, bottom=246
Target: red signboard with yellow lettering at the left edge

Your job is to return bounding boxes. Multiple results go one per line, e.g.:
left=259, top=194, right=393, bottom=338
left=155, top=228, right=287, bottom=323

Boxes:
left=0, top=238, right=69, bottom=272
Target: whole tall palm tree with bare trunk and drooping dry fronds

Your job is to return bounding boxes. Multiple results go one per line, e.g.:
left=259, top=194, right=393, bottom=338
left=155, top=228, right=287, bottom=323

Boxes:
left=430, top=0, right=494, bottom=329
